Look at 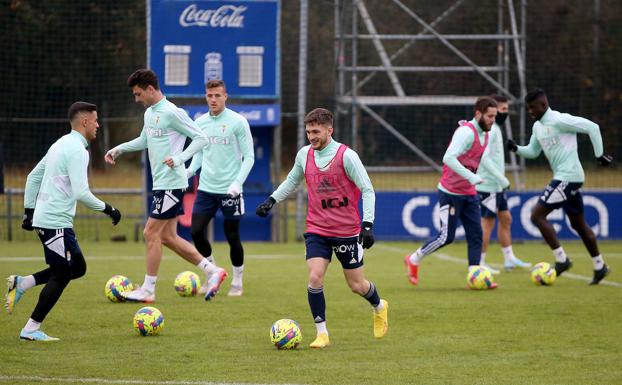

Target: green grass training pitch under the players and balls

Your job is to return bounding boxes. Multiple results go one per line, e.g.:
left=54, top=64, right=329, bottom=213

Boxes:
left=0, top=238, right=622, bottom=384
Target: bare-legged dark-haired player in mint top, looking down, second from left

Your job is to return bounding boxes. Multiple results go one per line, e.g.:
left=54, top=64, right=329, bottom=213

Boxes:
left=105, top=69, right=227, bottom=303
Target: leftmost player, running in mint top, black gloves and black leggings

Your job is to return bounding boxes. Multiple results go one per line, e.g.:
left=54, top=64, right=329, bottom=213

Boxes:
left=5, top=102, right=121, bottom=341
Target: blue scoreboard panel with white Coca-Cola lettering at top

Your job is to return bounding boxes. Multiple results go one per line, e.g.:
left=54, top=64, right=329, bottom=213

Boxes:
left=147, top=0, right=280, bottom=99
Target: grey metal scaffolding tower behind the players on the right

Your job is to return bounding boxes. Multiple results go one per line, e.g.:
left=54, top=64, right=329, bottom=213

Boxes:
left=334, top=0, right=526, bottom=189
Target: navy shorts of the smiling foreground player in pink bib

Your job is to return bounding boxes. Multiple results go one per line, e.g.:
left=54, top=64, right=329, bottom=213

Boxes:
left=304, top=233, right=363, bottom=269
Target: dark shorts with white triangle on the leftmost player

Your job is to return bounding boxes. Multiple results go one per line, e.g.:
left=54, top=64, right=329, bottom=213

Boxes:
left=35, top=227, right=82, bottom=265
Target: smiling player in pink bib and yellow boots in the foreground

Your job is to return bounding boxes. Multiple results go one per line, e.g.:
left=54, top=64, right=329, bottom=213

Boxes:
left=257, top=108, right=389, bottom=348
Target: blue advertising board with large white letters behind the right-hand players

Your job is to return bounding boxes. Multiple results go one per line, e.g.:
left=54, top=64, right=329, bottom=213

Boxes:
left=374, top=191, right=622, bottom=240
